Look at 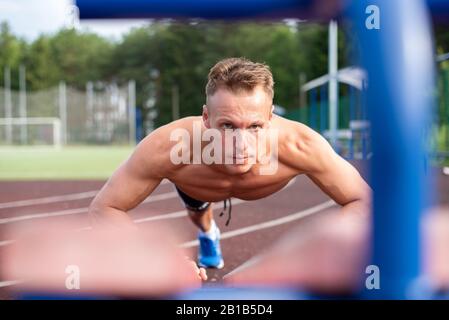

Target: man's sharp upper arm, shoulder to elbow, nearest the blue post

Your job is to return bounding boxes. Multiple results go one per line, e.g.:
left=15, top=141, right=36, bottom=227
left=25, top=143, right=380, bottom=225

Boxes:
left=289, top=125, right=371, bottom=216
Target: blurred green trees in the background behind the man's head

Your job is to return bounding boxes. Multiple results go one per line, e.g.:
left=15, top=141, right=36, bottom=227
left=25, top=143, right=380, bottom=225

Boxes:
left=0, top=20, right=446, bottom=126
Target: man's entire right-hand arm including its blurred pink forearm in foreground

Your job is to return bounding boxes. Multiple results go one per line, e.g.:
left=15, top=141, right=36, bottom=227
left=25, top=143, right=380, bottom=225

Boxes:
left=226, top=122, right=371, bottom=294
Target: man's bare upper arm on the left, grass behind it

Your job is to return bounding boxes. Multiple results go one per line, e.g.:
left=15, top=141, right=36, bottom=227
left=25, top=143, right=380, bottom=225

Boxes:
left=89, top=127, right=170, bottom=226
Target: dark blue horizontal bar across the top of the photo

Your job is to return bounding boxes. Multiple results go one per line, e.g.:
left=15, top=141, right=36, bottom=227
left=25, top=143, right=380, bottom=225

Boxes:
left=75, top=0, right=318, bottom=19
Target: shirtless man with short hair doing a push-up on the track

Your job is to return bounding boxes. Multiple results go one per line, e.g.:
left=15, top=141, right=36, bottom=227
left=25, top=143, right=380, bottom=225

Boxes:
left=89, top=58, right=371, bottom=274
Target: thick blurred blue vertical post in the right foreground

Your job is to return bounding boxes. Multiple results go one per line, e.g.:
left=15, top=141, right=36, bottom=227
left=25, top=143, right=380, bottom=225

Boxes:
left=351, top=0, right=434, bottom=299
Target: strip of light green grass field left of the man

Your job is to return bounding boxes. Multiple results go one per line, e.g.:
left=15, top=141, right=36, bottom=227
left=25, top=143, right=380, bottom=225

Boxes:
left=0, top=146, right=133, bottom=180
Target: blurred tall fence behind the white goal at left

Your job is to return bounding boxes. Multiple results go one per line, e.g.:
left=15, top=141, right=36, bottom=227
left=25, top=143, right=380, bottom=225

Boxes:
left=0, top=81, right=135, bottom=145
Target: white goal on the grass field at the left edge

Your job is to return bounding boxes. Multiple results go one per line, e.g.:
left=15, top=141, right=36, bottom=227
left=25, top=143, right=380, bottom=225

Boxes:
left=0, top=117, right=62, bottom=147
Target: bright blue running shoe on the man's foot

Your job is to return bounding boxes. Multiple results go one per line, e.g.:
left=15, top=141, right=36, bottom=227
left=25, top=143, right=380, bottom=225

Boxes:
left=198, top=227, right=224, bottom=269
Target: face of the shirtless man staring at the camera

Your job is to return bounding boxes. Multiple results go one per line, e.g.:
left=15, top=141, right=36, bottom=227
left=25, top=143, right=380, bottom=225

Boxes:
left=203, top=87, right=273, bottom=174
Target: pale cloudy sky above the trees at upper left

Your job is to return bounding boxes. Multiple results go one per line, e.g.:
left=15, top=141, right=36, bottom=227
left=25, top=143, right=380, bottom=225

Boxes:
left=0, top=0, right=150, bottom=41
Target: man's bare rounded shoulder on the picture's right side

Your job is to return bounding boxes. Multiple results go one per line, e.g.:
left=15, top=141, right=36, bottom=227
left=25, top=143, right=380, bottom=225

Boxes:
left=273, top=116, right=333, bottom=172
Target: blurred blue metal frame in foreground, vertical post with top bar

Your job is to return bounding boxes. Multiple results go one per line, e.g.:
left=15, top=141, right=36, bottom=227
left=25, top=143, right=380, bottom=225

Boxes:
left=77, top=0, right=438, bottom=299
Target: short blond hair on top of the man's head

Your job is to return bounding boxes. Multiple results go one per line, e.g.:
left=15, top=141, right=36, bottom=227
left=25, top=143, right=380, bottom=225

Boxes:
left=206, top=58, right=274, bottom=98
